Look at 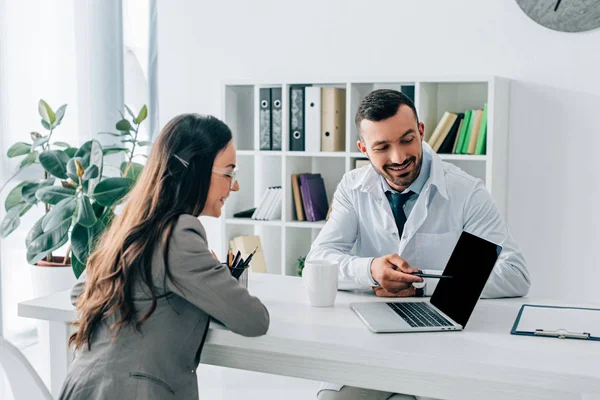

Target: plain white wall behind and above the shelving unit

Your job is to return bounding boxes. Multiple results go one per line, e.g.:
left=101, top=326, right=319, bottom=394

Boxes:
left=158, top=0, right=600, bottom=302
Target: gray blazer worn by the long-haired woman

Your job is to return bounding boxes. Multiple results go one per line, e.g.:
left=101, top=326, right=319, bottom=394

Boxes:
left=59, top=215, right=269, bottom=400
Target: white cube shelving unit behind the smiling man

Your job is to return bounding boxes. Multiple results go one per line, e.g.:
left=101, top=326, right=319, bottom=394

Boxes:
left=220, top=76, right=510, bottom=275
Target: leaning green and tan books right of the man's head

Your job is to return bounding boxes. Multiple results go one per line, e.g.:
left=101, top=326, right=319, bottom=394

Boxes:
left=427, top=104, right=487, bottom=155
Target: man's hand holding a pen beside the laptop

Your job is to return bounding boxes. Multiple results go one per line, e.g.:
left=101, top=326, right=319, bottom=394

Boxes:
left=371, top=254, right=423, bottom=293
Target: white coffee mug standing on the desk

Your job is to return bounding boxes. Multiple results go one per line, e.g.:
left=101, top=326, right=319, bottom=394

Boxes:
left=302, top=260, right=339, bottom=307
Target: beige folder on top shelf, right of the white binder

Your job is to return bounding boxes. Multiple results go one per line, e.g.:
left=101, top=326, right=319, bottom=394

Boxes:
left=321, top=87, right=346, bottom=151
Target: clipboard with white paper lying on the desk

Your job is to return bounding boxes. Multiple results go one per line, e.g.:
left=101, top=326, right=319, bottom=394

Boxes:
left=510, top=304, right=600, bottom=341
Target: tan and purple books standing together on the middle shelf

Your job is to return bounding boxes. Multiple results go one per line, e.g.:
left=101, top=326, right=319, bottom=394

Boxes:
left=292, top=173, right=329, bottom=221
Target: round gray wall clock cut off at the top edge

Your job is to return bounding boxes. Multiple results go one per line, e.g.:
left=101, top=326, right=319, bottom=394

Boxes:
left=516, top=0, right=600, bottom=32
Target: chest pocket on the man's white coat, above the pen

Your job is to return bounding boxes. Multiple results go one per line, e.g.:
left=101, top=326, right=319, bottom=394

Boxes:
left=412, top=231, right=462, bottom=271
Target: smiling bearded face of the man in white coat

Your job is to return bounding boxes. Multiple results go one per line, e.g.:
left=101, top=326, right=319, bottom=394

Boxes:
left=357, top=105, right=425, bottom=192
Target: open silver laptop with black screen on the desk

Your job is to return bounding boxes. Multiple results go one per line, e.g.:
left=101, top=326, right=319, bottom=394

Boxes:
left=350, top=232, right=502, bottom=333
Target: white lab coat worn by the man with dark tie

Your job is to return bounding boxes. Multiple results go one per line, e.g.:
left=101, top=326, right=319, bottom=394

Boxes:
left=307, top=142, right=530, bottom=298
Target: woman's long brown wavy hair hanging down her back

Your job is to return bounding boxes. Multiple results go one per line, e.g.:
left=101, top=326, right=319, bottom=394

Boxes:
left=69, top=114, right=232, bottom=349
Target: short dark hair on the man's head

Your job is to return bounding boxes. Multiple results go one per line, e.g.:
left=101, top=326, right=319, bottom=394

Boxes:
left=354, top=89, right=419, bottom=137
